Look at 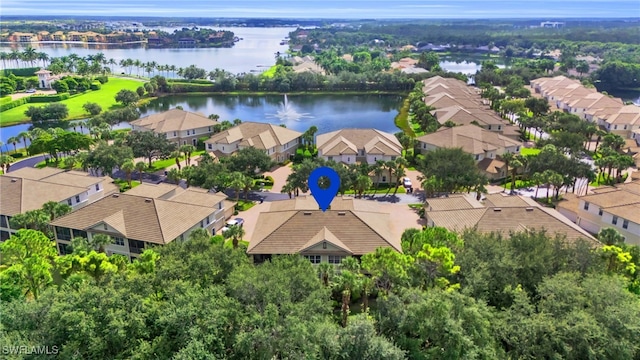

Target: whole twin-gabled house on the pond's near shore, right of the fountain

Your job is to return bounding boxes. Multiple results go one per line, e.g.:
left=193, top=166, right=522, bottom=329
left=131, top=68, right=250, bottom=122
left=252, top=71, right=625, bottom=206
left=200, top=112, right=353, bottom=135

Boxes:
left=316, top=129, right=402, bottom=164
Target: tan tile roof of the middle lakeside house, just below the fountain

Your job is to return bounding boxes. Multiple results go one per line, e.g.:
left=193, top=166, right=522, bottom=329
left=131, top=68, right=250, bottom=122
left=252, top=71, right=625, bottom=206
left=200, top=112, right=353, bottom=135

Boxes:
left=205, top=121, right=302, bottom=150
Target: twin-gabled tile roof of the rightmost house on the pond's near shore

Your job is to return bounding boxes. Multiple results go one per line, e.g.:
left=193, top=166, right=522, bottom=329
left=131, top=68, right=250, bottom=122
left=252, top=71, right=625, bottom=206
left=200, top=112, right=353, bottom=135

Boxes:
left=316, top=129, right=402, bottom=156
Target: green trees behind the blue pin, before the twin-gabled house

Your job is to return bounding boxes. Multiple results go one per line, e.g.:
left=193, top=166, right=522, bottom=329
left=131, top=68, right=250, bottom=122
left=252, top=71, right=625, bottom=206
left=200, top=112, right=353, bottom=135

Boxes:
left=282, top=157, right=408, bottom=197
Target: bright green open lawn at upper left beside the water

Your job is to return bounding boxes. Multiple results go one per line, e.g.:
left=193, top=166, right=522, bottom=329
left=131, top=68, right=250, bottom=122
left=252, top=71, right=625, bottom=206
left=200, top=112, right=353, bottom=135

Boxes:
left=0, top=77, right=143, bottom=126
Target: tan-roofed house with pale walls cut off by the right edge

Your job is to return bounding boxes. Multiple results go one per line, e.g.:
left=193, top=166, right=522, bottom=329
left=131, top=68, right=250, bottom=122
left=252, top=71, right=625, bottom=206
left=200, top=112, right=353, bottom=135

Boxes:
left=558, top=180, right=640, bottom=245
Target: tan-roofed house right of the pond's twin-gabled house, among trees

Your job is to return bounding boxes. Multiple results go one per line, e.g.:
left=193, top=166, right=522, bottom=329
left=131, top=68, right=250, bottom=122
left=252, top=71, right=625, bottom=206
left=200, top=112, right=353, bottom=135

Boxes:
left=417, top=125, right=522, bottom=180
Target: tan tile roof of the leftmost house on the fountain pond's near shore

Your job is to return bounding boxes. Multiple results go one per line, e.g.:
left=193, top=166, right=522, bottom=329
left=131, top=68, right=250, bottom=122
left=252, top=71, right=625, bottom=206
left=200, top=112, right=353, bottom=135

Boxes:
left=130, top=109, right=218, bottom=133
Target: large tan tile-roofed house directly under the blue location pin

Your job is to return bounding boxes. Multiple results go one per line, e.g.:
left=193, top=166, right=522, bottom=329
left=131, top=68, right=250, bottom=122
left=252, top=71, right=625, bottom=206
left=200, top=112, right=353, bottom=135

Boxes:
left=247, top=196, right=402, bottom=265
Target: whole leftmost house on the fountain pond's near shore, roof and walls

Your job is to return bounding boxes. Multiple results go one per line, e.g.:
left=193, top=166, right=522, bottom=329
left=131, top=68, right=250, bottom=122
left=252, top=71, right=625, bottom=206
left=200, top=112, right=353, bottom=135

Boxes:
left=130, top=109, right=218, bottom=146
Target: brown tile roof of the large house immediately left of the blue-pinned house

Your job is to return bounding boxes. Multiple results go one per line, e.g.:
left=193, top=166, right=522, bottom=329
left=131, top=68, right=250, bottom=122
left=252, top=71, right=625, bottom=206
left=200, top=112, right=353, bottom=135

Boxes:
left=52, top=193, right=215, bottom=244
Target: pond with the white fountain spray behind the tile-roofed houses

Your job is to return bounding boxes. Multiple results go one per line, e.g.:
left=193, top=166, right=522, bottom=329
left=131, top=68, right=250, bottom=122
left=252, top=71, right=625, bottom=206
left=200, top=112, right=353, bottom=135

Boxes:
left=0, top=94, right=403, bottom=151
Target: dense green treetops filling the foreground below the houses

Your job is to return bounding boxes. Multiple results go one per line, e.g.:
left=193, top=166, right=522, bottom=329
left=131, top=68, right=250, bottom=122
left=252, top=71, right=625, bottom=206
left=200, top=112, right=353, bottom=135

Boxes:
left=0, top=228, right=640, bottom=359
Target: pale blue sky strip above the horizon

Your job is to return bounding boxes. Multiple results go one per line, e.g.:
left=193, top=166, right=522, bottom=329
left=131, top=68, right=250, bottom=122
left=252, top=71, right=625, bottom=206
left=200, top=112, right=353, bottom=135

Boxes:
left=0, top=0, right=640, bottom=19
